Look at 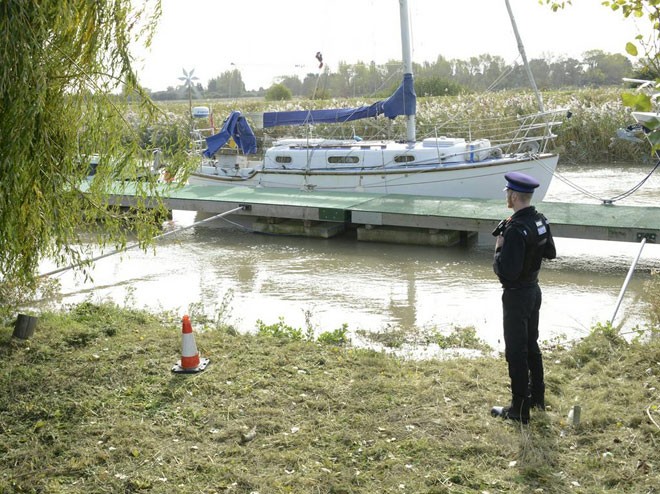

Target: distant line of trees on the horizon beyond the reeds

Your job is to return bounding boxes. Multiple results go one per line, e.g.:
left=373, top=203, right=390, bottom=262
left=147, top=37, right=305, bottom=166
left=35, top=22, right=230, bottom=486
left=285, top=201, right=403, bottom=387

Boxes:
left=151, top=47, right=635, bottom=103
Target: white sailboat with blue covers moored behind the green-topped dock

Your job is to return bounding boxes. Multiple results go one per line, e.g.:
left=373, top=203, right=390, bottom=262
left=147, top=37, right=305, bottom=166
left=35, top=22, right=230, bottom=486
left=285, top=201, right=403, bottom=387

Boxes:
left=189, top=0, right=565, bottom=200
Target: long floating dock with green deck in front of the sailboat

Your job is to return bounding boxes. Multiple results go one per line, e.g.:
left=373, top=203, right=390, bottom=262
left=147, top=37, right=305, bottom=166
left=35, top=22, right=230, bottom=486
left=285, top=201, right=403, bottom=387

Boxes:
left=111, top=183, right=660, bottom=245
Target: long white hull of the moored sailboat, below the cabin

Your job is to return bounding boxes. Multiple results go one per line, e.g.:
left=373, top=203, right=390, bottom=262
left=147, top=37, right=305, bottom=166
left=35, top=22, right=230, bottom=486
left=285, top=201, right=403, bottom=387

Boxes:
left=188, top=154, right=559, bottom=200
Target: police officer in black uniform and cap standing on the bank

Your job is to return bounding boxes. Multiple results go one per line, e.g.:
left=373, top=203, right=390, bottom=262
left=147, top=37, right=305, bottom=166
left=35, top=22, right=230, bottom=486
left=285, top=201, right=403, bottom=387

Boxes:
left=491, top=172, right=557, bottom=423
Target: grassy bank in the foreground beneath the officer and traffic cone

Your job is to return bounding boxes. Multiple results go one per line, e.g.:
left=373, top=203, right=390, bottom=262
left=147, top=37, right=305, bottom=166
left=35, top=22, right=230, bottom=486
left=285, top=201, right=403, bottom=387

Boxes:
left=0, top=304, right=660, bottom=494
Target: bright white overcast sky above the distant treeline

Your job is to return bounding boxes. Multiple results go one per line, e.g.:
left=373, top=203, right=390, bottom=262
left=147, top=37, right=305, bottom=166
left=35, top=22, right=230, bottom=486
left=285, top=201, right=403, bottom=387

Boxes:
left=136, top=0, right=649, bottom=91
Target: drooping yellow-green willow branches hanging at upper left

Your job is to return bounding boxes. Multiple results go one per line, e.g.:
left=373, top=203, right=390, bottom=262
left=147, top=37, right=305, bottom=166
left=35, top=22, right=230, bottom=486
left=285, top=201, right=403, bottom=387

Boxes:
left=0, top=0, right=180, bottom=298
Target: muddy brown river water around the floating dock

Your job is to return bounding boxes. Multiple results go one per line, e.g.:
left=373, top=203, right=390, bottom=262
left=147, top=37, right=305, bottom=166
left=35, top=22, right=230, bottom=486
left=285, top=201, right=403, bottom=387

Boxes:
left=43, top=165, right=660, bottom=355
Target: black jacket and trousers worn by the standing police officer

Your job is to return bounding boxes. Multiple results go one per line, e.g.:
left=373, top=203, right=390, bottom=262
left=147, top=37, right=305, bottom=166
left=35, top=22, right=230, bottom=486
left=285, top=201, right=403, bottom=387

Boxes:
left=493, top=206, right=557, bottom=407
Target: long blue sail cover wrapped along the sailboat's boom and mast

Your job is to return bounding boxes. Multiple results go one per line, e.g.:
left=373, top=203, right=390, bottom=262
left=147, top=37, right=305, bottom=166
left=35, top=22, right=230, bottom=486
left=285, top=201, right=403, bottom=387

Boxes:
left=264, top=74, right=417, bottom=127
